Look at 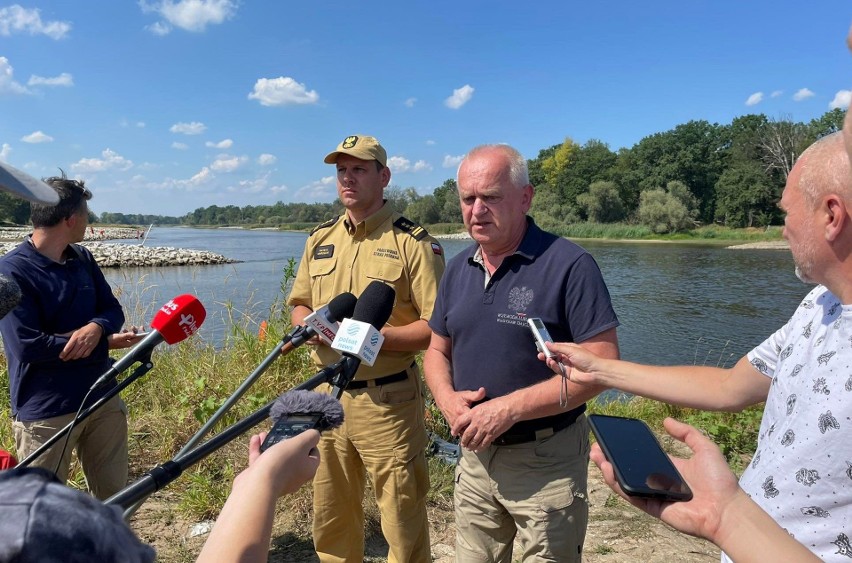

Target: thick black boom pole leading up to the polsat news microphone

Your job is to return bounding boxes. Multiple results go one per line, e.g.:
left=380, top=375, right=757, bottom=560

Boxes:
left=109, top=361, right=345, bottom=514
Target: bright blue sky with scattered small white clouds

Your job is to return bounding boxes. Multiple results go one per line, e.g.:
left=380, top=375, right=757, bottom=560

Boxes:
left=0, top=0, right=852, bottom=215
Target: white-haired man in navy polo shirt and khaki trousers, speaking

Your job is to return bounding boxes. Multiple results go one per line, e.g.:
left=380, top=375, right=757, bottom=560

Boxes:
left=424, top=145, right=618, bottom=562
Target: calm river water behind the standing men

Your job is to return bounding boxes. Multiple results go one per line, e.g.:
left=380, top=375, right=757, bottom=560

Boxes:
left=104, top=228, right=810, bottom=366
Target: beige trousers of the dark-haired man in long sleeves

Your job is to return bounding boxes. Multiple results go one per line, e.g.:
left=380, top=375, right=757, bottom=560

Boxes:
left=12, top=396, right=127, bottom=500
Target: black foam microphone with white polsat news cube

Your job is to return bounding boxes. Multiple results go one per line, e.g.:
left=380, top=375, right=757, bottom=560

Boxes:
left=331, top=281, right=396, bottom=397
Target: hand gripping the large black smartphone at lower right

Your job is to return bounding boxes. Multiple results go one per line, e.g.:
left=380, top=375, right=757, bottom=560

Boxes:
left=591, top=418, right=745, bottom=541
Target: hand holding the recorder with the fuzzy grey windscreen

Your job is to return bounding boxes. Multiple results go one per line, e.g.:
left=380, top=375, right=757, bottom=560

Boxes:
left=234, top=429, right=320, bottom=496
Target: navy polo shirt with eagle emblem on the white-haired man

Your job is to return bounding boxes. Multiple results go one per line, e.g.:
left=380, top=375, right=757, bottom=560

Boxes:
left=429, top=217, right=619, bottom=408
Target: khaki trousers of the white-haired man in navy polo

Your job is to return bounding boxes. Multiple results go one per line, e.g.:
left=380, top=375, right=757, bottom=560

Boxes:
left=454, top=415, right=589, bottom=563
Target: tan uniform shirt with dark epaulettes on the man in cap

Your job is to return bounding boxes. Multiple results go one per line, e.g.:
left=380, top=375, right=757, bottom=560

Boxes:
left=287, top=203, right=444, bottom=380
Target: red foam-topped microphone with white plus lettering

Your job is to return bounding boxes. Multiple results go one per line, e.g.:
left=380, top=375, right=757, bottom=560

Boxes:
left=93, top=294, right=207, bottom=388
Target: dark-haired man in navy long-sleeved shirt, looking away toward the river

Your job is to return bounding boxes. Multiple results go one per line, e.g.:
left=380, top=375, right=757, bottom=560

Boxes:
left=0, top=176, right=141, bottom=499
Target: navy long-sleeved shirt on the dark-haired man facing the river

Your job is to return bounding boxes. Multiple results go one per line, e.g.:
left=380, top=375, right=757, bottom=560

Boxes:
left=0, top=241, right=124, bottom=420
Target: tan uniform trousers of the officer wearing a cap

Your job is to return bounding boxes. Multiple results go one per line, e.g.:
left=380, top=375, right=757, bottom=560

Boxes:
left=313, top=367, right=432, bottom=563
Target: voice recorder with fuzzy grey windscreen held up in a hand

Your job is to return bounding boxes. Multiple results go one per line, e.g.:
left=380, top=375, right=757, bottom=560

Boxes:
left=260, top=390, right=343, bottom=452
